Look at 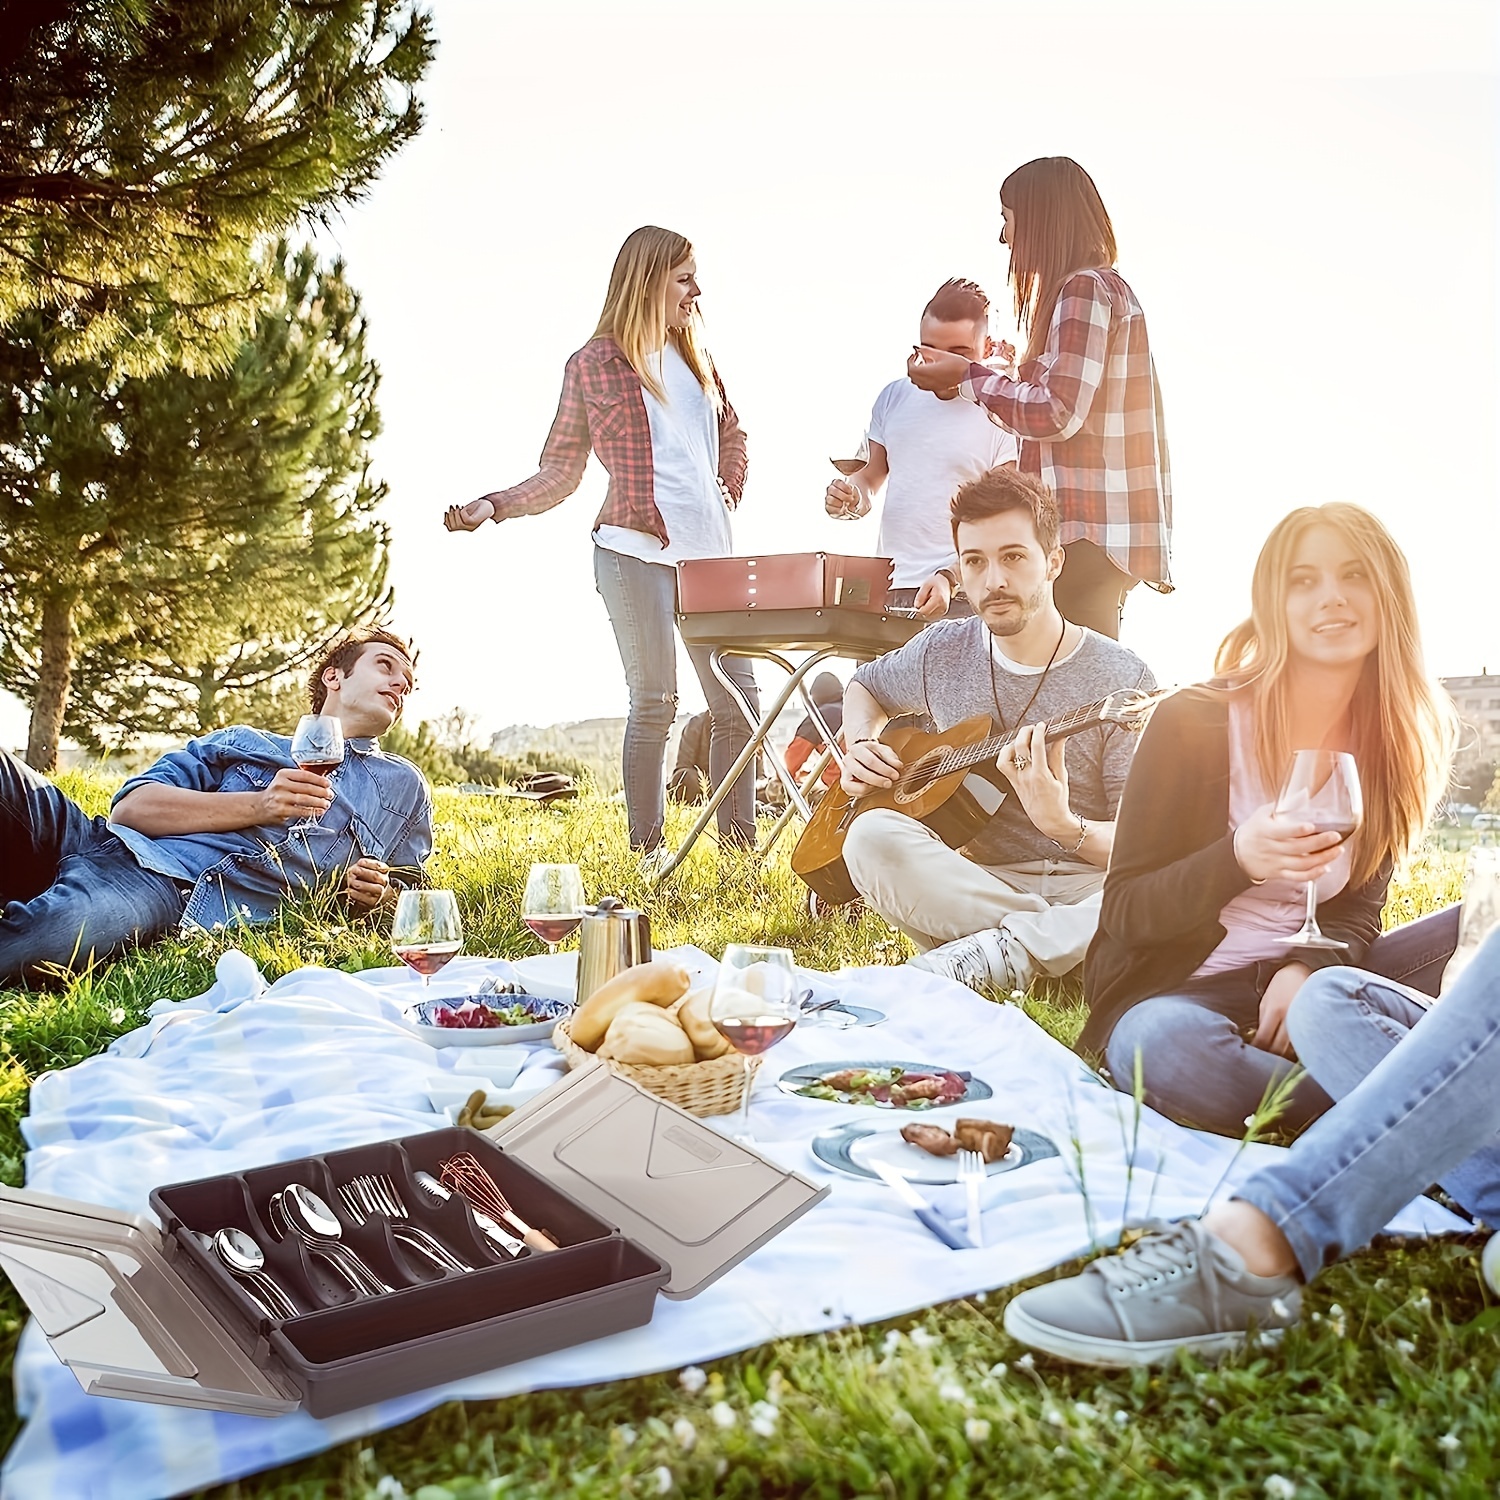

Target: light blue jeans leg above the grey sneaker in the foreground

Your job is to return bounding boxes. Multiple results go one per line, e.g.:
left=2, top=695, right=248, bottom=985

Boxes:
left=1235, top=933, right=1500, bottom=1280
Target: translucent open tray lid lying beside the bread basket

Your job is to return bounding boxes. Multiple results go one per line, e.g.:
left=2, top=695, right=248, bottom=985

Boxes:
left=486, top=1062, right=828, bottom=1298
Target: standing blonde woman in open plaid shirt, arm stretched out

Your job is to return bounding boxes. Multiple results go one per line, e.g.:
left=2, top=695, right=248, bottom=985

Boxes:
left=444, top=225, right=758, bottom=852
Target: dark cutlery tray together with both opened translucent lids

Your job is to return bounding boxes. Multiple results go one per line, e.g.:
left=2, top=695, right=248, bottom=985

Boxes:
left=0, top=1064, right=828, bottom=1418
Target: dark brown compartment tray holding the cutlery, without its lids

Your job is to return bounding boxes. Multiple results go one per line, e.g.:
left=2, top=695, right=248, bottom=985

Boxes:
left=152, top=1128, right=668, bottom=1416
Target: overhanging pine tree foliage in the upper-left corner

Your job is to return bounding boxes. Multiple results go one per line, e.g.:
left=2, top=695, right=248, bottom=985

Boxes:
left=0, top=0, right=435, bottom=374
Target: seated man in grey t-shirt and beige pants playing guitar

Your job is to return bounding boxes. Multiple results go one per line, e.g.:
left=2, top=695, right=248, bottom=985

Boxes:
left=842, top=468, right=1155, bottom=990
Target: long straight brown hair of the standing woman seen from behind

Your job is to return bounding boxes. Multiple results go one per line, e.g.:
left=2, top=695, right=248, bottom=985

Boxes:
left=1001, top=156, right=1116, bottom=360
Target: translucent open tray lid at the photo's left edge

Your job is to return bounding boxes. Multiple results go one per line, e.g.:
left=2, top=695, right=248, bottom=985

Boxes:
left=0, top=1187, right=300, bottom=1416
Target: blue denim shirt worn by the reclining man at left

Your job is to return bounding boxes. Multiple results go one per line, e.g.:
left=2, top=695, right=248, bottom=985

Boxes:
left=110, top=725, right=432, bottom=929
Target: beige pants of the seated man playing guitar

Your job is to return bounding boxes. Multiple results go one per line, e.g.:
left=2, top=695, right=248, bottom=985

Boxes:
left=845, top=807, right=1104, bottom=975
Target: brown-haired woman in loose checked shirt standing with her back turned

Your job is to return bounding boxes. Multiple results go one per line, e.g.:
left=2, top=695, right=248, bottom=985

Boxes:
left=906, top=156, right=1172, bottom=636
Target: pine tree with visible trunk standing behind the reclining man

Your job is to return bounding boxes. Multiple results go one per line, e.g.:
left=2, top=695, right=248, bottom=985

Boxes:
left=0, top=243, right=390, bottom=770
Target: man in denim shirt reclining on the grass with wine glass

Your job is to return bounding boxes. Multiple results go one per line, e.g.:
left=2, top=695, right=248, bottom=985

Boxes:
left=0, top=630, right=432, bottom=983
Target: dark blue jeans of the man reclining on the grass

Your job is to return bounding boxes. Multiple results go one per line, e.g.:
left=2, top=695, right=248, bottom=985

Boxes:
left=0, top=750, right=183, bottom=984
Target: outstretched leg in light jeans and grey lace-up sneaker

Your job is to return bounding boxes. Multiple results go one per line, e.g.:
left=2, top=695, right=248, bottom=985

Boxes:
left=1005, top=932, right=1500, bottom=1365
